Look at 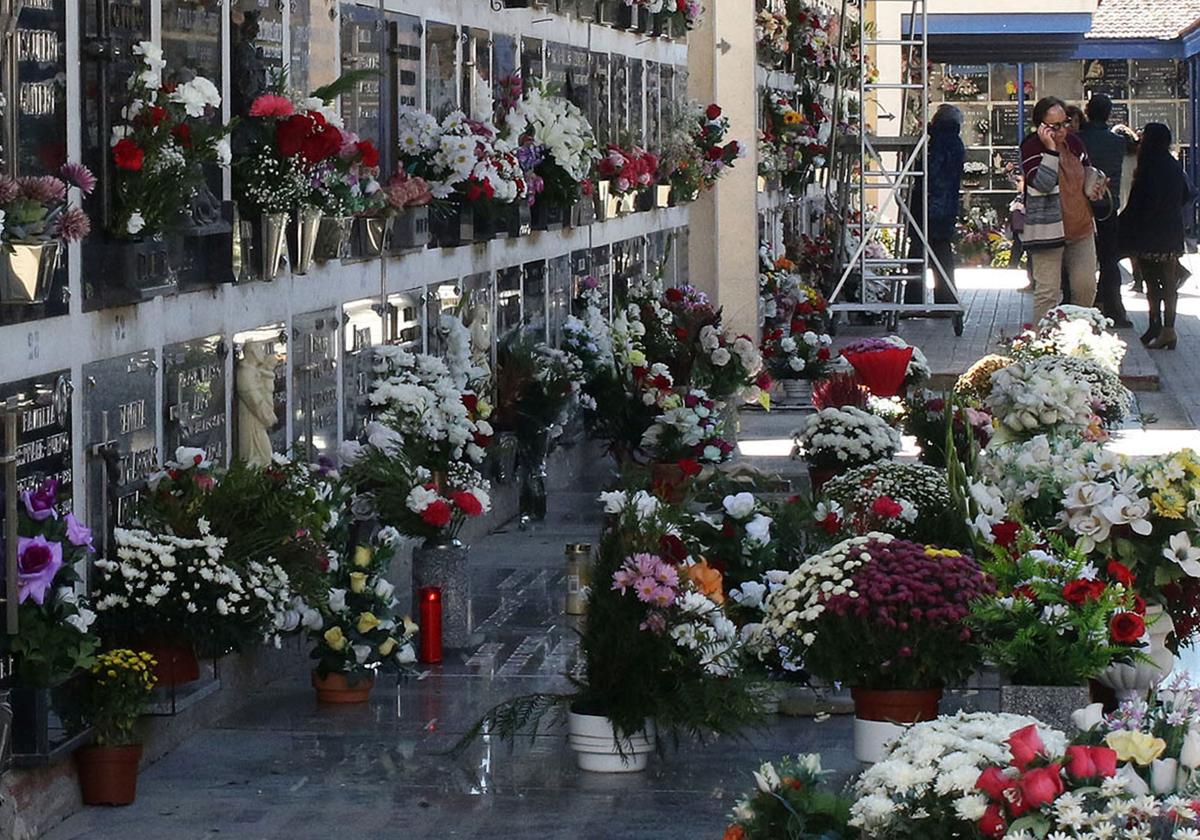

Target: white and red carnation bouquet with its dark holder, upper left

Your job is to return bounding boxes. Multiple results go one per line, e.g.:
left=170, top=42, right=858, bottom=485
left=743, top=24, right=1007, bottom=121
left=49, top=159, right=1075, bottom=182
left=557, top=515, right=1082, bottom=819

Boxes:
left=103, top=41, right=232, bottom=294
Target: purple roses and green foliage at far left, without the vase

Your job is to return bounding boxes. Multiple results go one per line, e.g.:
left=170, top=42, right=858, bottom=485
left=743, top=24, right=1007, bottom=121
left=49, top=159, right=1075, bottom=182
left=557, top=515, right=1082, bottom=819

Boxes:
left=0, top=479, right=100, bottom=688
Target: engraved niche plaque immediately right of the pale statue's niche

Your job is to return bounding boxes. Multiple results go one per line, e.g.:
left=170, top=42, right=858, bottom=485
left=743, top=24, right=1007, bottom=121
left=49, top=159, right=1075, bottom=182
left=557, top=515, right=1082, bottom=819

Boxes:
left=292, top=310, right=338, bottom=461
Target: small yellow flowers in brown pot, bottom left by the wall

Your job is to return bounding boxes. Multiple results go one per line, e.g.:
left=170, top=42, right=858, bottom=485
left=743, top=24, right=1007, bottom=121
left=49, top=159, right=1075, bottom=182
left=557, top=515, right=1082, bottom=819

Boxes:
left=74, top=648, right=157, bottom=805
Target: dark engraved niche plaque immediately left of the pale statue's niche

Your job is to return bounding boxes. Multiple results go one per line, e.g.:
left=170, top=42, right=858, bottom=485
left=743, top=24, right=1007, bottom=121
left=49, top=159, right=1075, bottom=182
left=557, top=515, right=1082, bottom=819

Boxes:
left=162, top=335, right=229, bottom=464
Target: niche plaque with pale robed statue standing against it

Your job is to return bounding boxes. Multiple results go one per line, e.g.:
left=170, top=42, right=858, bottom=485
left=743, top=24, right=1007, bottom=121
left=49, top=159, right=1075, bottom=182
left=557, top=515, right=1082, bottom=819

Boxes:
left=233, top=324, right=290, bottom=466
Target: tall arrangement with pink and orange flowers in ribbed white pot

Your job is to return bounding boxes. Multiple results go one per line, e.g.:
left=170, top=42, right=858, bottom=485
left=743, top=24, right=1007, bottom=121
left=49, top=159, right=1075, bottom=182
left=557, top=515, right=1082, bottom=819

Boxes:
left=458, top=491, right=762, bottom=773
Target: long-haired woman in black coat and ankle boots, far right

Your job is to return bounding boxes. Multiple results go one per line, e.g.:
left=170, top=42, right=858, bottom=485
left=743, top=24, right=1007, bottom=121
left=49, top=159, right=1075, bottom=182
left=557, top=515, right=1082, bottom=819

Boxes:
left=1121, top=122, right=1194, bottom=350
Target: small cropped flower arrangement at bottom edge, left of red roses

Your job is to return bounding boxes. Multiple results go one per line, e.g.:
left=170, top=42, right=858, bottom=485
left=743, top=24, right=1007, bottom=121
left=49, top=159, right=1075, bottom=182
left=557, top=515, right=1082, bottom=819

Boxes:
left=722, top=755, right=853, bottom=840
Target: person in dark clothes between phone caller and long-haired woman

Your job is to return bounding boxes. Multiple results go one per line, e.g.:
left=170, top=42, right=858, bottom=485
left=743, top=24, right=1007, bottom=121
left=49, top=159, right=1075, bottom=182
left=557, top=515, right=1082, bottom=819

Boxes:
left=1079, top=94, right=1133, bottom=329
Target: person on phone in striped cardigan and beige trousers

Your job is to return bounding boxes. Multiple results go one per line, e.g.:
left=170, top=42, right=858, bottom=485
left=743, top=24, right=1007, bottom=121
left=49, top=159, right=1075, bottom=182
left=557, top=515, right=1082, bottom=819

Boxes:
left=1021, top=96, right=1096, bottom=323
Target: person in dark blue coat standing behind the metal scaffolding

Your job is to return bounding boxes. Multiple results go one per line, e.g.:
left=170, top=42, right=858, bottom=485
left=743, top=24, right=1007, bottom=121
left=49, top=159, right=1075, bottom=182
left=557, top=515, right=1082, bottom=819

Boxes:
left=904, top=104, right=966, bottom=304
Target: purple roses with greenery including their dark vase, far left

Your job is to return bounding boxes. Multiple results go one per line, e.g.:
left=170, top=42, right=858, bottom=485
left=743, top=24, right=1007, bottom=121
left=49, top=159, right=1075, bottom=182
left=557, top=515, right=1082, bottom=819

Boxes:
left=0, top=479, right=100, bottom=757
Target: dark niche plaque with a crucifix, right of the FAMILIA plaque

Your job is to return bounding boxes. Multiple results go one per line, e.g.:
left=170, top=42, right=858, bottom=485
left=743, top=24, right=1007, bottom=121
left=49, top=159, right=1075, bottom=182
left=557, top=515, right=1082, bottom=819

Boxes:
left=83, top=350, right=160, bottom=553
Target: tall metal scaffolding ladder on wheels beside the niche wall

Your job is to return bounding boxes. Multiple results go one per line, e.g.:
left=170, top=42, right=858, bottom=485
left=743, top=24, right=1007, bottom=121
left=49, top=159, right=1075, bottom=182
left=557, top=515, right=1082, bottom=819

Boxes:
left=829, top=0, right=965, bottom=336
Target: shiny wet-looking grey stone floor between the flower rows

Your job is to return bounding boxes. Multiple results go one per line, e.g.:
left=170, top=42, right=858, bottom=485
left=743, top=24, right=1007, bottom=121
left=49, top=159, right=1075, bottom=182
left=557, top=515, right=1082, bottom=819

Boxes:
left=39, top=480, right=853, bottom=840
